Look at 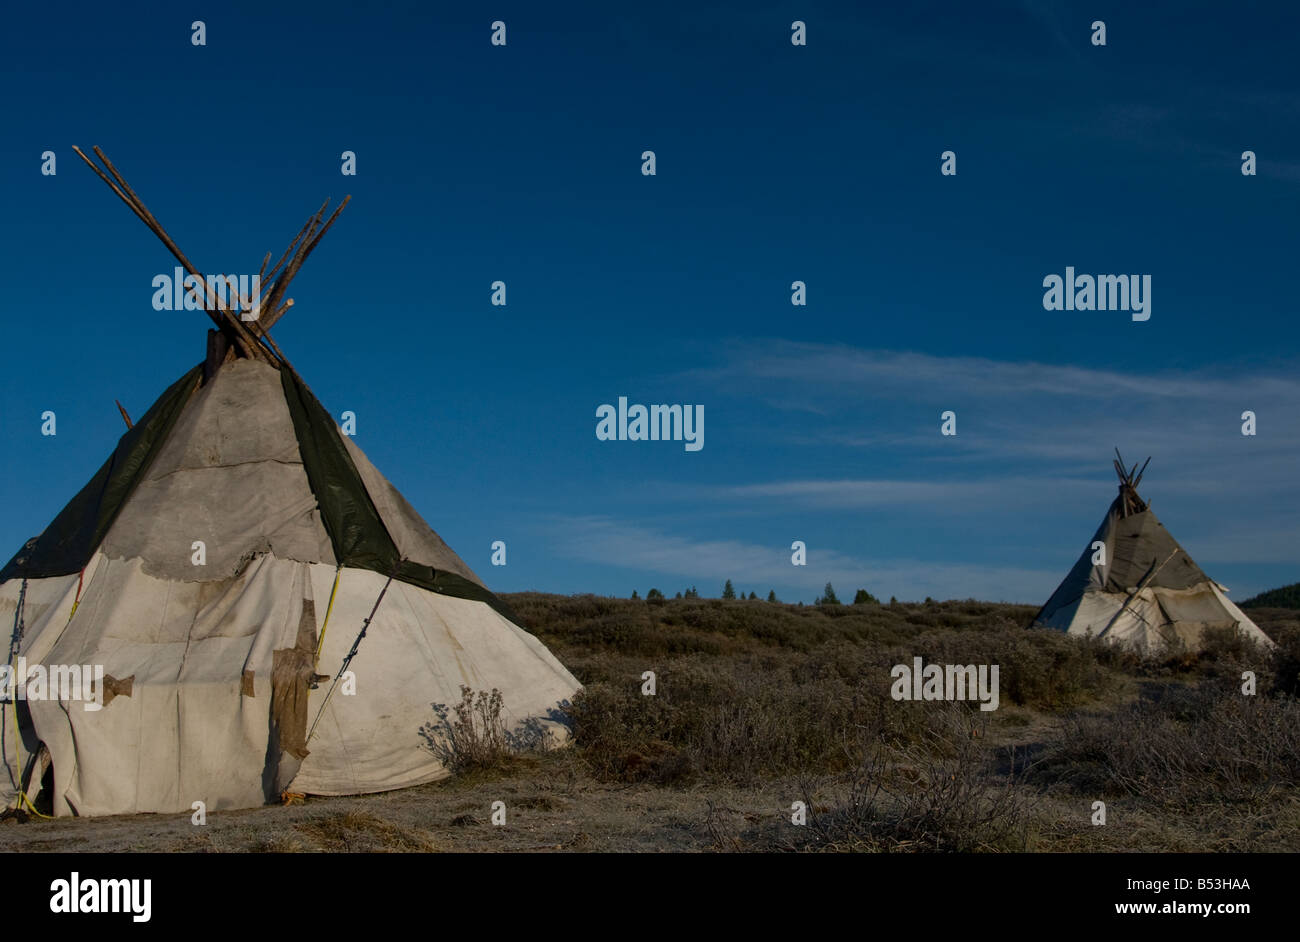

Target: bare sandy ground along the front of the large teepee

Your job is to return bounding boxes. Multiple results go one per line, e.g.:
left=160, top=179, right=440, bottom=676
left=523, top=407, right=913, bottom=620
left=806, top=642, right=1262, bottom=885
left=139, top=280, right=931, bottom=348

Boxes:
left=0, top=750, right=794, bottom=852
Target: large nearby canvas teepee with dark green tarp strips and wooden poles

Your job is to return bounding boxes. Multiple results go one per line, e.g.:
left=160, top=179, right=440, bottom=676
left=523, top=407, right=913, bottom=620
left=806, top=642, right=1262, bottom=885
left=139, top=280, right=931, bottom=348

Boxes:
left=0, top=148, right=579, bottom=815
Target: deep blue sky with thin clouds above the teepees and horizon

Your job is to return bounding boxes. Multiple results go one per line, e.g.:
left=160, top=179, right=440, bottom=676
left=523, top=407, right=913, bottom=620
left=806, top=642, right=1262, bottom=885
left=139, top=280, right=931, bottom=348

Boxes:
left=0, top=0, right=1300, bottom=603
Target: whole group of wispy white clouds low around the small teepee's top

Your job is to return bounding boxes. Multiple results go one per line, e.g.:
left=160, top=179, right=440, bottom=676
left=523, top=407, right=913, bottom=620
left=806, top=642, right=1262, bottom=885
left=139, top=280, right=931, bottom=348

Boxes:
left=545, top=340, right=1300, bottom=603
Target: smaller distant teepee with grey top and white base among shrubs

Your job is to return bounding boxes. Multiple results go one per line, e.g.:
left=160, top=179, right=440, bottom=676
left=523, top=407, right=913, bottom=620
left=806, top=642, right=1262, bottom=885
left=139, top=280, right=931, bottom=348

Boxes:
left=1034, top=452, right=1273, bottom=654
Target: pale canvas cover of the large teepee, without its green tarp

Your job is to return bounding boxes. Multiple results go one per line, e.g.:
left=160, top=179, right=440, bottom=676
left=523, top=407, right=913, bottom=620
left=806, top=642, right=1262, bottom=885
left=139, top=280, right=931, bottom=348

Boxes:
left=0, top=360, right=579, bottom=815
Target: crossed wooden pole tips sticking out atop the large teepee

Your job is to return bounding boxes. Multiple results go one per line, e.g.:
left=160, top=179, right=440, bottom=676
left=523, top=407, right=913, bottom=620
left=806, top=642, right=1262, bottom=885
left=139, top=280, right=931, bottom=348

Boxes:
left=73, top=144, right=352, bottom=371
